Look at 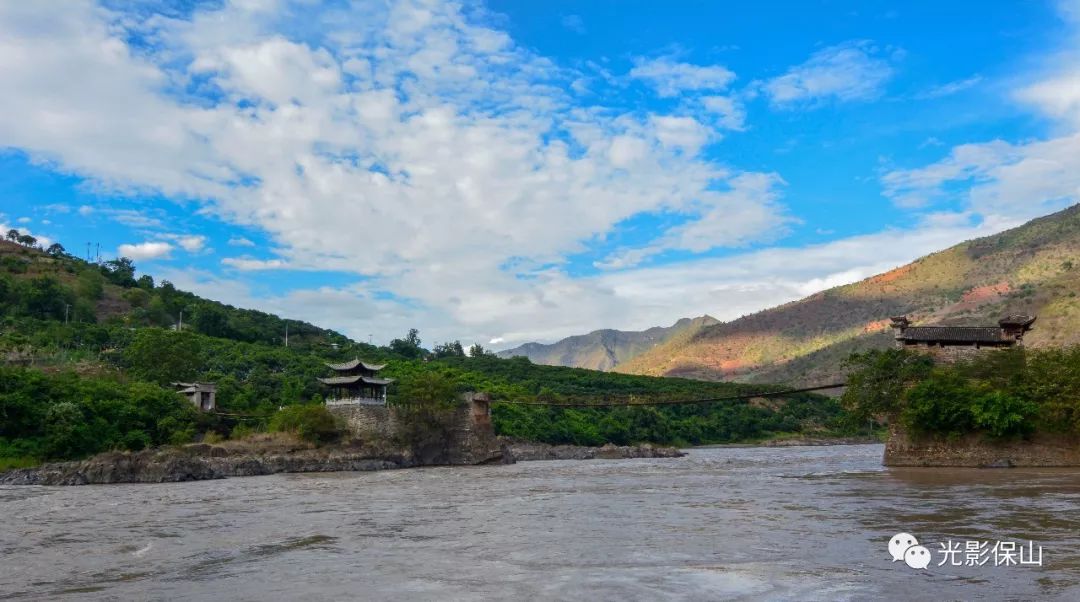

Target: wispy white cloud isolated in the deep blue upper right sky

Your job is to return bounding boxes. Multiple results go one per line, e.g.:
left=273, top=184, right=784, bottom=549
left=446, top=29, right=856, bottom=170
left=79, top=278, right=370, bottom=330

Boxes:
left=761, top=41, right=893, bottom=108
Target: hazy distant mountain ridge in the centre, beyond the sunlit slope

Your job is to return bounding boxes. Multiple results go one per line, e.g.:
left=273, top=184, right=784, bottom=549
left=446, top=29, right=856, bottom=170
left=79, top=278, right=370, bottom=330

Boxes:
left=498, top=316, right=718, bottom=370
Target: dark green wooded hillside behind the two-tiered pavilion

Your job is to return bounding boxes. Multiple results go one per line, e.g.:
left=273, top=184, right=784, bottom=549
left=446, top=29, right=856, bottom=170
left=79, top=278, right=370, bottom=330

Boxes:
left=0, top=236, right=855, bottom=468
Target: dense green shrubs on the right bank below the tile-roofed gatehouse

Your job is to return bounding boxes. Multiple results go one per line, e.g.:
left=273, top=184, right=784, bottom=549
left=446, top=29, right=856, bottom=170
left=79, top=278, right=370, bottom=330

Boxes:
left=841, top=346, right=1080, bottom=440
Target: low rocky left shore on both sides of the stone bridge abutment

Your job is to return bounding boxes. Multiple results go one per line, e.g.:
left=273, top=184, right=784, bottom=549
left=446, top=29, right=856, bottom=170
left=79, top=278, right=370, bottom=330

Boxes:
left=0, top=433, right=685, bottom=485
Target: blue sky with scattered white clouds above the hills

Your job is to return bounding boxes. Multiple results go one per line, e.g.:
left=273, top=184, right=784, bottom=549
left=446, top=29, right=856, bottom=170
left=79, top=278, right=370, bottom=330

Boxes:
left=0, top=0, right=1080, bottom=348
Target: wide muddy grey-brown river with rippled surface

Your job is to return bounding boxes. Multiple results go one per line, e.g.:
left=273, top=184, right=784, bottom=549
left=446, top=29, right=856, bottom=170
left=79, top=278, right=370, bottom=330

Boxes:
left=0, top=445, right=1080, bottom=602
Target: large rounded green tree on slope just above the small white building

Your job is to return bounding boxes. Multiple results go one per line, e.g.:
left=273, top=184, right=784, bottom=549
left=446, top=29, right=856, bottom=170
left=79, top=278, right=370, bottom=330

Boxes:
left=123, top=329, right=202, bottom=385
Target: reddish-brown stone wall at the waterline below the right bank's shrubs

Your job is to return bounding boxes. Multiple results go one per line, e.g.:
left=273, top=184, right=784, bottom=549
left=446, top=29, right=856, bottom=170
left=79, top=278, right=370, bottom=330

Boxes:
left=882, top=425, right=1080, bottom=468
